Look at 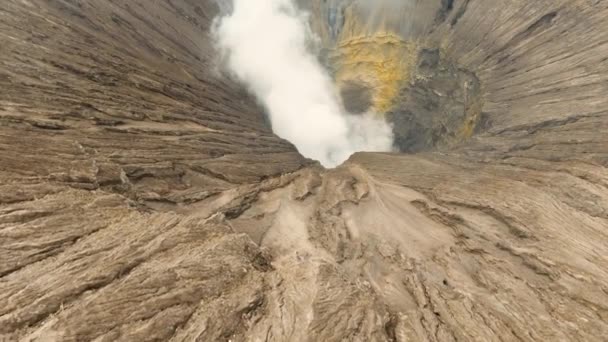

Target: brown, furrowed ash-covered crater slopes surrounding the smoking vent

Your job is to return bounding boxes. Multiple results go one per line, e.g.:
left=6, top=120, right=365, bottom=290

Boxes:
left=0, top=0, right=608, bottom=341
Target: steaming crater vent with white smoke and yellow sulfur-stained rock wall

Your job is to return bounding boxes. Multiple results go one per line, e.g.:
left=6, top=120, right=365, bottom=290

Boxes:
left=216, top=0, right=490, bottom=166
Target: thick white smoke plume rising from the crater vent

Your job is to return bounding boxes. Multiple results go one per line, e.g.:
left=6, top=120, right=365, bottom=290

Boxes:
left=215, top=0, right=393, bottom=167
